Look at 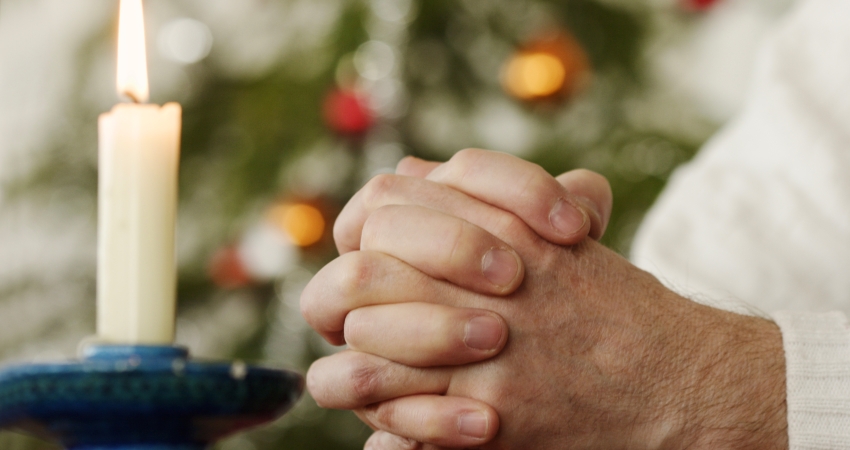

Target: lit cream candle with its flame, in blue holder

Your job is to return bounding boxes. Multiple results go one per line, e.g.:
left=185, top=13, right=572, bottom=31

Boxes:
left=97, top=0, right=181, bottom=345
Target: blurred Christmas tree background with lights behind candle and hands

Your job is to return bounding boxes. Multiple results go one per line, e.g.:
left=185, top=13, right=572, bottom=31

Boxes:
left=0, top=0, right=790, bottom=450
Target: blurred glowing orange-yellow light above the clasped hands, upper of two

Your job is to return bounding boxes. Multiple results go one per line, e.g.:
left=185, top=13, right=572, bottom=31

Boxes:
left=504, top=52, right=567, bottom=100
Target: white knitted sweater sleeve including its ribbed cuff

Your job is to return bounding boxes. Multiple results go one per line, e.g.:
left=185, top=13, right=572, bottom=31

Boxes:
left=632, top=0, right=850, bottom=450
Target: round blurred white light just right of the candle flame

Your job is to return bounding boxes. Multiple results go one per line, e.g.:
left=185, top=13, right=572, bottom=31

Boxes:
left=157, top=18, right=213, bottom=64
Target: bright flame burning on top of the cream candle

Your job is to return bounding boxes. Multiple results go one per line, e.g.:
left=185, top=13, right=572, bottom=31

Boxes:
left=116, top=0, right=150, bottom=103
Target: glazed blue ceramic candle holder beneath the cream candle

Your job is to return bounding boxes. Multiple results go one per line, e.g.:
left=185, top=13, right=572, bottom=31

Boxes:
left=0, top=345, right=304, bottom=450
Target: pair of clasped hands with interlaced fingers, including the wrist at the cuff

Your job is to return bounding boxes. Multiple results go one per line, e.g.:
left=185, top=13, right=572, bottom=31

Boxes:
left=301, top=150, right=787, bottom=450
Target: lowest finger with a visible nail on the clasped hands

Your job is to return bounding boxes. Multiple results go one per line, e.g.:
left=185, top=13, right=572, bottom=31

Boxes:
left=355, top=395, right=499, bottom=448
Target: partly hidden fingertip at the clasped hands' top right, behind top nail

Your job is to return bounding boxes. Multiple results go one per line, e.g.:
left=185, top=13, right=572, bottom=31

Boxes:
left=555, top=169, right=614, bottom=239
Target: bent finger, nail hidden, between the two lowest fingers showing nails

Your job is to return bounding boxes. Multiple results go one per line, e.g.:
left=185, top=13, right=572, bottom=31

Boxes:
left=307, top=350, right=451, bottom=409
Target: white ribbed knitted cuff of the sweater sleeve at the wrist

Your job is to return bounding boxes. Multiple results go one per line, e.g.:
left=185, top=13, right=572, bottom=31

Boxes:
left=773, top=311, right=850, bottom=450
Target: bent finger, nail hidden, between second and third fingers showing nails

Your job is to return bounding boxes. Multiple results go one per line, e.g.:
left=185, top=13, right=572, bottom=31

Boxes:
left=301, top=251, right=476, bottom=345
